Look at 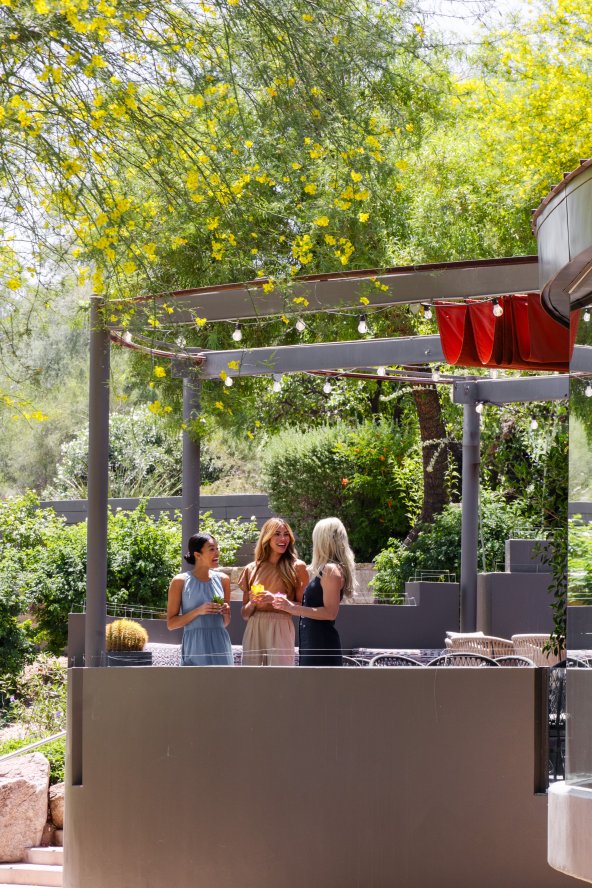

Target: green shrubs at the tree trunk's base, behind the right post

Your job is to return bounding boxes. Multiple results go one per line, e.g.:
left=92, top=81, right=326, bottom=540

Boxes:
left=371, top=491, right=523, bottom=604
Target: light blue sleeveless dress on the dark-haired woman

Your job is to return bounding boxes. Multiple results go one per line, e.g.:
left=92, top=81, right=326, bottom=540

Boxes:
left=181, top=571, right=232, bottom=666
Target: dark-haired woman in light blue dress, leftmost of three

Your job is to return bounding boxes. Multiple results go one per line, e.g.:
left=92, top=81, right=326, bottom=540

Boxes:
left=167, top=533, right=232, bottom=666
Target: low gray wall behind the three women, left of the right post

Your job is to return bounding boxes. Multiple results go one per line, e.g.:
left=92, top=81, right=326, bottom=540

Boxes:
left=68, top=583, right=459, bottom=666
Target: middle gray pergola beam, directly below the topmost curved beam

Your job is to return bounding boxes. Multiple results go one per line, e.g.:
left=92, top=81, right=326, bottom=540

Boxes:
left=183, top=336, right=444, bottom=379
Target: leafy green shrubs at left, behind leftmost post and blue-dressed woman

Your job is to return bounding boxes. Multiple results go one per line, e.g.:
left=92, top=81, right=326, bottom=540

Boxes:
left=0, top=494, right=257, bottom=654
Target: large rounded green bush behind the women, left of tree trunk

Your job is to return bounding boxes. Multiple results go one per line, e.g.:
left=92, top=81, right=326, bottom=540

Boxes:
left=263, top=422, right=421, bottom=561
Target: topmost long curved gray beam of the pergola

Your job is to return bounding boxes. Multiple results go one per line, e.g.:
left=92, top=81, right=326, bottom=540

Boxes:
left=110, top=256, right=539, bottom=329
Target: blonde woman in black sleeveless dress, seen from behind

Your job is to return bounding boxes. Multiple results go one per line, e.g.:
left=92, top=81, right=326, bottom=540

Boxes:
left=273, top=518, right=356, bottom=666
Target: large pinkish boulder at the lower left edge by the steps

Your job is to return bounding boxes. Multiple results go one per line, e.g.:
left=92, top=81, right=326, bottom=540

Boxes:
left=0, top=752, right=49, bottom=863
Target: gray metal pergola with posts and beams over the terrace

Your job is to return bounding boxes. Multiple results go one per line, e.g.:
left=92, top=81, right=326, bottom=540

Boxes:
left=85, top=256, right=569, bottom=666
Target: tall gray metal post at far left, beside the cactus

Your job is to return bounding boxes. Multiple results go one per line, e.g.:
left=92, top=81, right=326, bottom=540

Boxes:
left=84, top=296, right=110, bottom=666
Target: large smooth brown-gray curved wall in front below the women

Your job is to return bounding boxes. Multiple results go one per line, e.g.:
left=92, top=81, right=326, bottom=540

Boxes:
left=64, top=667, right=573, bottom=888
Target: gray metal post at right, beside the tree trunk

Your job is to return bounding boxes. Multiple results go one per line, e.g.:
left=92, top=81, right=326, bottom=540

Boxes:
left=460, top=401, right=481, bottom=632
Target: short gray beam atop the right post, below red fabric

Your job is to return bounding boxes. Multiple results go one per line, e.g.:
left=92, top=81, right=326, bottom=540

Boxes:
left=453, top=373, right=569, bottom=405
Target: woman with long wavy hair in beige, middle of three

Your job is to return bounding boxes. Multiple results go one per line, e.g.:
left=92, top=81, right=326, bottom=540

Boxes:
left=238, top=518, right=308, bottom=666
